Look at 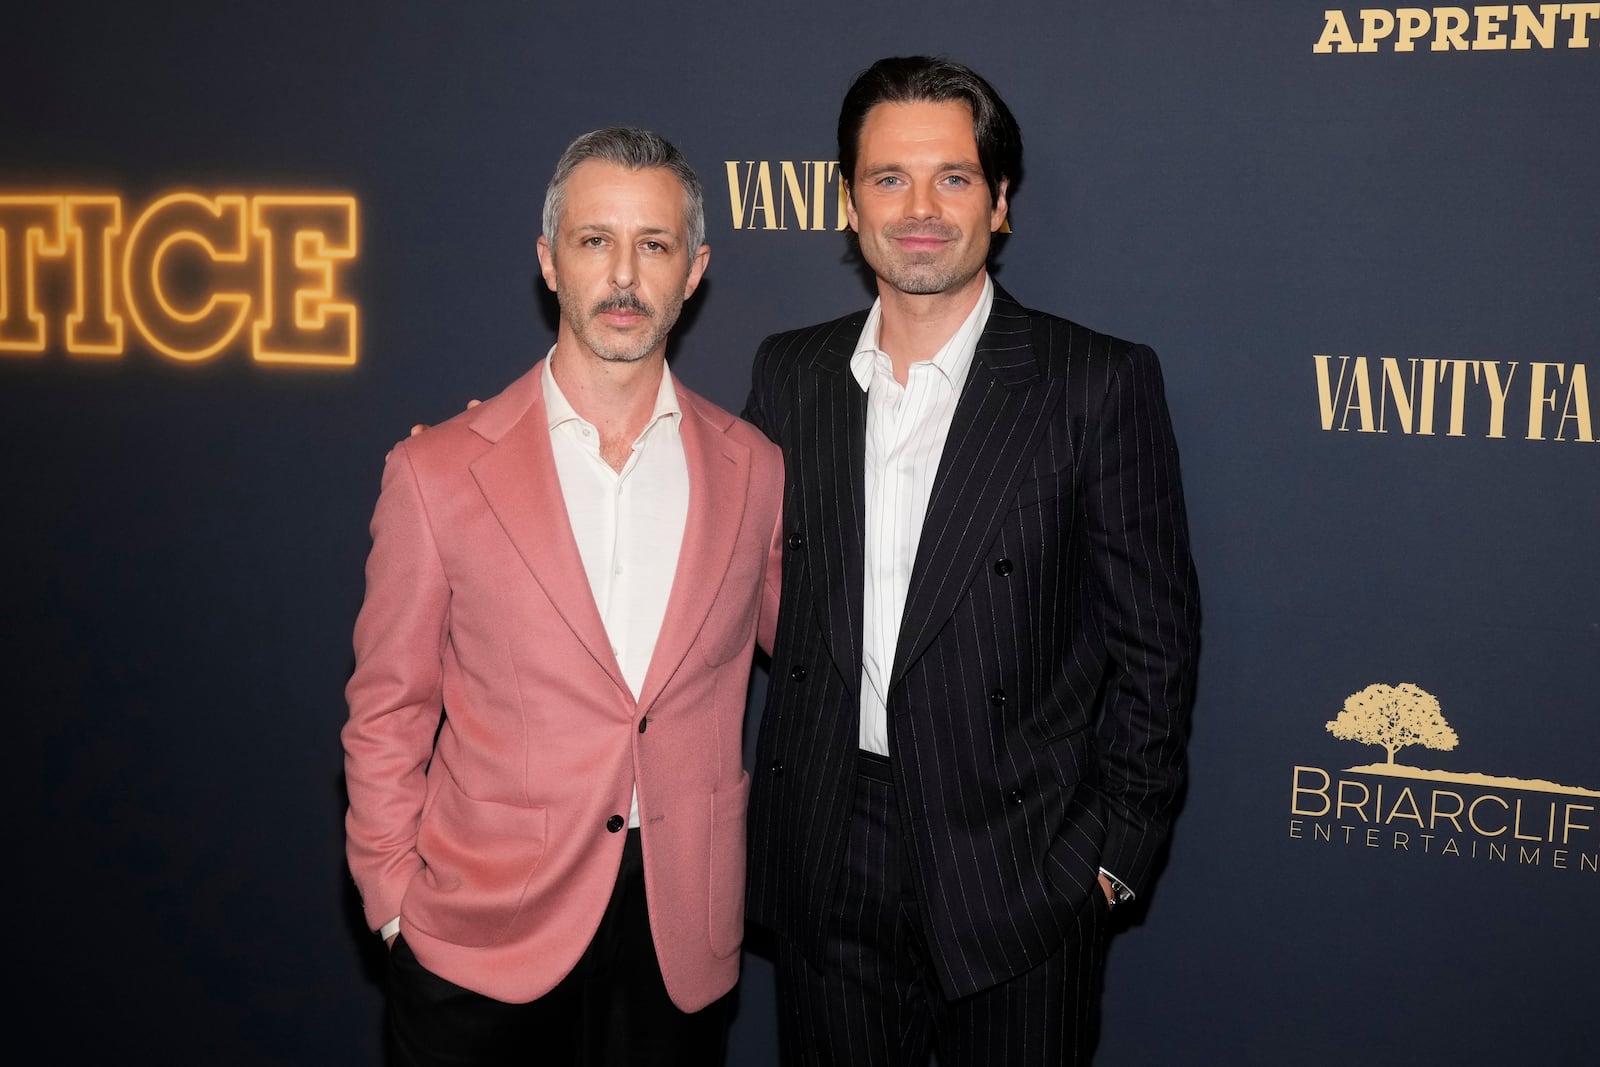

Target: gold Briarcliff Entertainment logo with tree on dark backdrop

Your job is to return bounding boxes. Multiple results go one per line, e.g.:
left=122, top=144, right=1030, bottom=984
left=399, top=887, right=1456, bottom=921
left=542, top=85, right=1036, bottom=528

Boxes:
left=1288, top=683, right=1600, bottom=875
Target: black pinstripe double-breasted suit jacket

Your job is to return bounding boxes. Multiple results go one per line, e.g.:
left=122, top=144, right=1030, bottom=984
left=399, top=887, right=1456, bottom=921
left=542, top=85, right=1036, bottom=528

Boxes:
left=744, top=288, right=1200, bottom=997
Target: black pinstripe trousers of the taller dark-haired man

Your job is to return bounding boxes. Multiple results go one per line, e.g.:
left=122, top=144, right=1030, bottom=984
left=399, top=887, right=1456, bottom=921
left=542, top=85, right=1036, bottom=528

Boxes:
left=778, top=753, right=1110, bottom=1067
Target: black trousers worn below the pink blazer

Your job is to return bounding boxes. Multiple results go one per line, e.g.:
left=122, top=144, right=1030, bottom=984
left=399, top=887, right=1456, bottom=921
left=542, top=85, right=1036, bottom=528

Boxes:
left=389, top=830, right=731, bottom=1067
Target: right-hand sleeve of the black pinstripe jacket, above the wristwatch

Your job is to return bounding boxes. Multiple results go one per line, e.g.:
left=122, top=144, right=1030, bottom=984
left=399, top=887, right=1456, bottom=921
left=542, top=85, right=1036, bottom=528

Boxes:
left=1083, top=346, right=1200, bottom=893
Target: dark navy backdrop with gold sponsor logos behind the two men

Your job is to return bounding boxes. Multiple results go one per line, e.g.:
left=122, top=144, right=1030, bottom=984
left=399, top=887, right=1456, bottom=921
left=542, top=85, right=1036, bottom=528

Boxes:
left=0, top=0, right=1600, bottom=1065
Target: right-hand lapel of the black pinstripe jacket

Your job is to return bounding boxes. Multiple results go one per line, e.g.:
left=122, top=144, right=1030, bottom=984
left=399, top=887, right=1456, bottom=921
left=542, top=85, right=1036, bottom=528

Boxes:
left=889, top=288, right=1059, bottom=686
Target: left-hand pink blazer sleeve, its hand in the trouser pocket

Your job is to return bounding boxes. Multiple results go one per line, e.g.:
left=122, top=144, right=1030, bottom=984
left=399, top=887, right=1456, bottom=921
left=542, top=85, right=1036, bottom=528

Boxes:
left=342, top=443, right=450, bottom=929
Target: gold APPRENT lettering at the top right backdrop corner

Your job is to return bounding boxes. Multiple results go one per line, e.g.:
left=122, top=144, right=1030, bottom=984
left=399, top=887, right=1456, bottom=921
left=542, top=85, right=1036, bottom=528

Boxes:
left=1310, top=3, right=1600, bottom=54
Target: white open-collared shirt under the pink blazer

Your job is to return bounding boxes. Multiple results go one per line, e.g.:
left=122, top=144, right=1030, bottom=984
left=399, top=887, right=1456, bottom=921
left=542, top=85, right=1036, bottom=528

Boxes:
left=544, top=349, right=690, bottom=827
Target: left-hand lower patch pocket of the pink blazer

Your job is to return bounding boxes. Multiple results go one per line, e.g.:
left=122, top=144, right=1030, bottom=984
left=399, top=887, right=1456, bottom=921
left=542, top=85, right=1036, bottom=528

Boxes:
left=402, top=768, right=546, bottom=947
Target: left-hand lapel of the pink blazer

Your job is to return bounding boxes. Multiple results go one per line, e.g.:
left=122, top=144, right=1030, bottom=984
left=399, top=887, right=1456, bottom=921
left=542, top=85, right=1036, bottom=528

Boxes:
left=470, top=366, right=632, bottom=699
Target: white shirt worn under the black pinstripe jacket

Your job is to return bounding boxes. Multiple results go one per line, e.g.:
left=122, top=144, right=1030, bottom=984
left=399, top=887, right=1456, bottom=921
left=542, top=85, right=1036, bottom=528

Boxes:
left=850, top=277, right=995, bottom=755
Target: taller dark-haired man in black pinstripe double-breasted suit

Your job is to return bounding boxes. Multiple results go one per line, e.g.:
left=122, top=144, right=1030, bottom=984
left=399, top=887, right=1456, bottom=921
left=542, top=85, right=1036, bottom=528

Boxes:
left=746, top=58, right=1198, bottom=1067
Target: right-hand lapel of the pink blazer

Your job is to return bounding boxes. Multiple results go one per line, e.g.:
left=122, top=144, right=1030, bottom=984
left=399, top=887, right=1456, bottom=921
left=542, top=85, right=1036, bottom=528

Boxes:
left=638, top=382, right=750, bottom=709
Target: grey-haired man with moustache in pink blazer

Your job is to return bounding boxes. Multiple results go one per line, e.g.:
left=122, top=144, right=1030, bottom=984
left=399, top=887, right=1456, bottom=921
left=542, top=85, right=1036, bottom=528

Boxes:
left=342, top=128, right=782, bottom=1064
